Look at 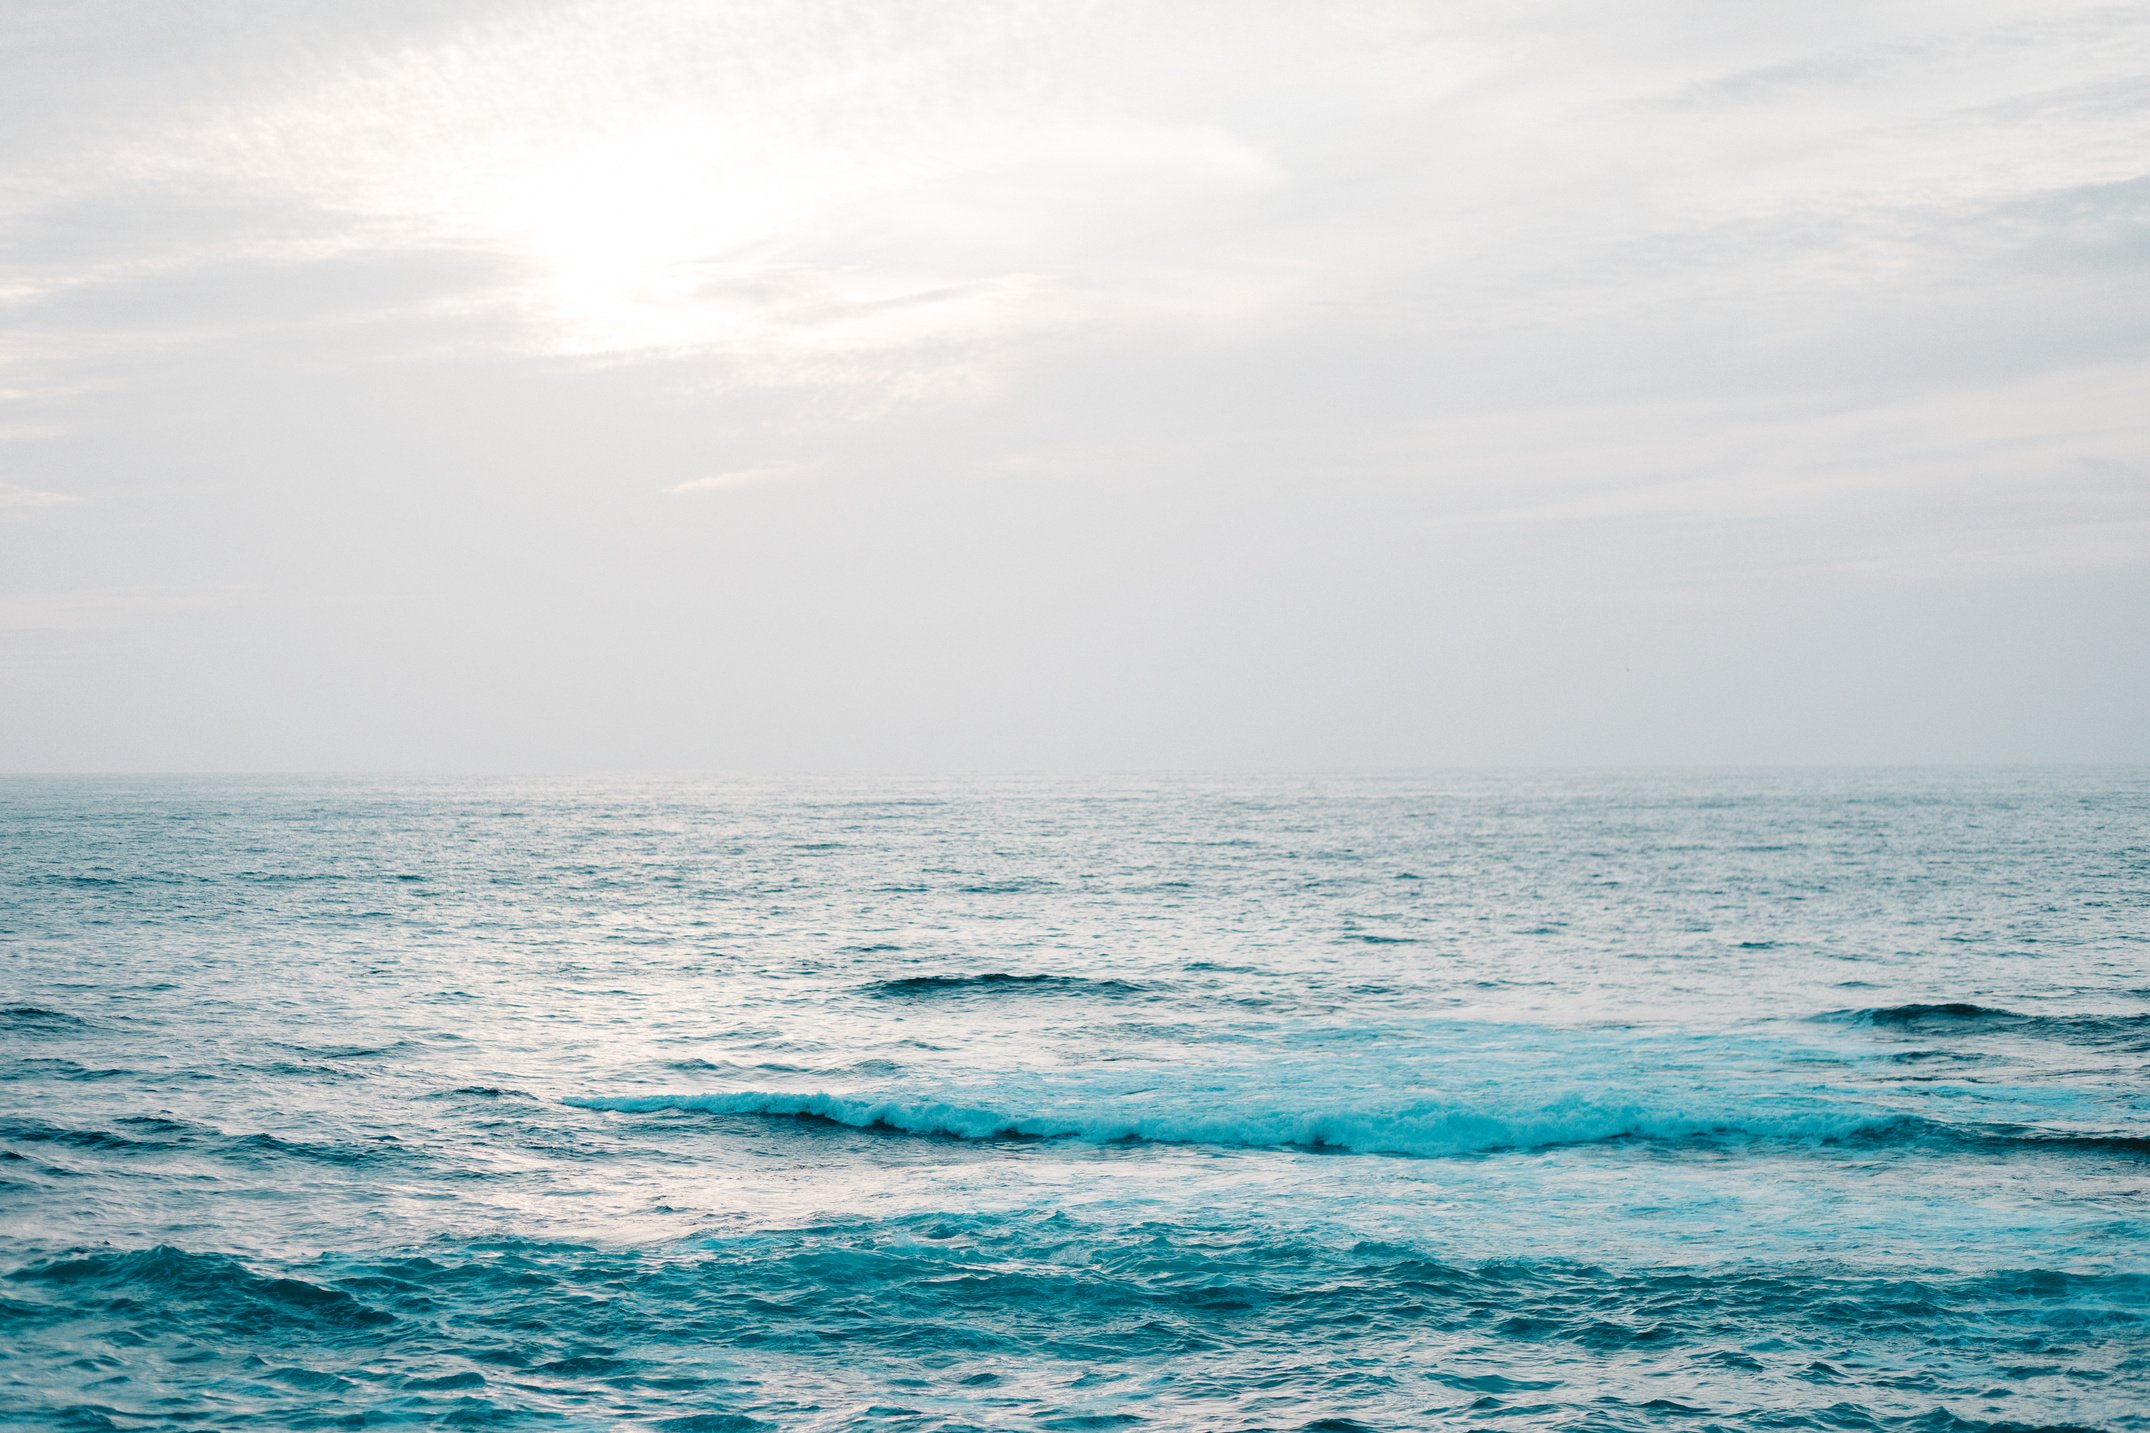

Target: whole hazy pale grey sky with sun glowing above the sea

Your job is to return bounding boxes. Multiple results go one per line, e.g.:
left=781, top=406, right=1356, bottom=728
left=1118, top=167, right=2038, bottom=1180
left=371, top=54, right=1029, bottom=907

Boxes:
left=0, top=0, right=2150, bottom=771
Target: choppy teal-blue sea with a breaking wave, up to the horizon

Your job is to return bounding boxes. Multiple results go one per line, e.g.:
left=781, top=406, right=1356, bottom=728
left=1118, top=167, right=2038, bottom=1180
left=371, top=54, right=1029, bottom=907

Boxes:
left=0, top=771, right=2150, bottom=1431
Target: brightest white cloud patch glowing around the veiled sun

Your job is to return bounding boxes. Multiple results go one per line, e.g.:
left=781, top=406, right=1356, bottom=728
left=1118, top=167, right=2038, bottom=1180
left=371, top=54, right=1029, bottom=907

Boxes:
left=37, top=0, right=1294, bottom=391
